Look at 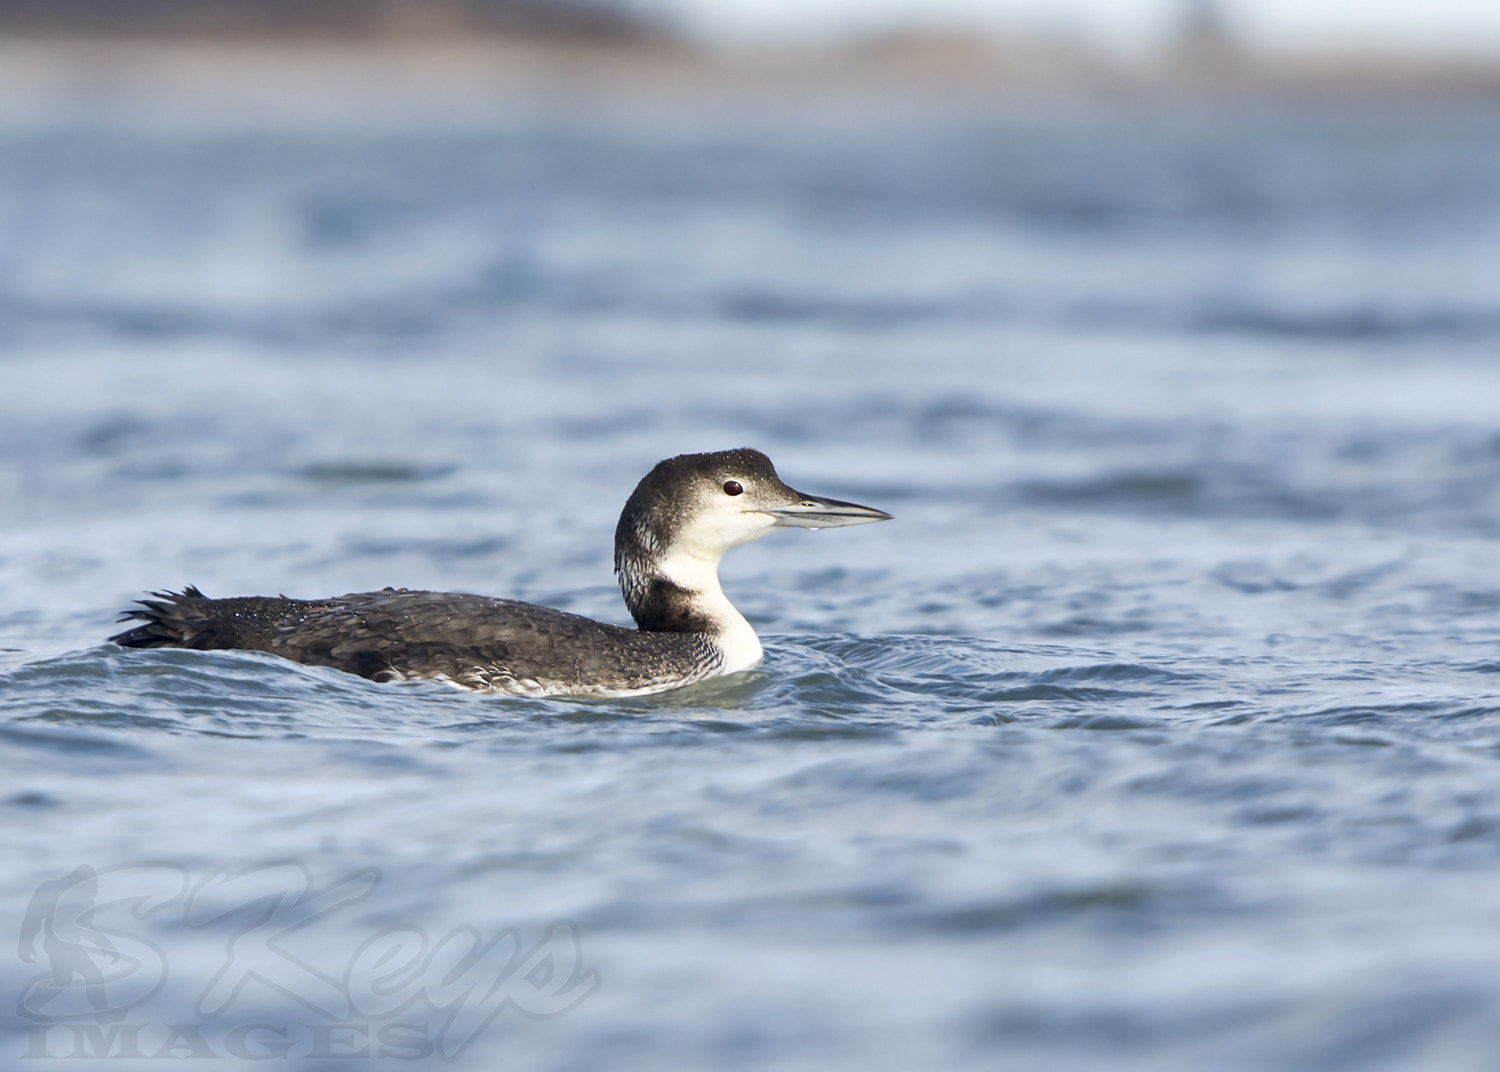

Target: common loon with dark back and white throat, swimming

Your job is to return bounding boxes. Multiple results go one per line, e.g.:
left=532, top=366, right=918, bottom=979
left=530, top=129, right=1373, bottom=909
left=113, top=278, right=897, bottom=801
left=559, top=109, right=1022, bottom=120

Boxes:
left=110, top=448, right=891, bottom=696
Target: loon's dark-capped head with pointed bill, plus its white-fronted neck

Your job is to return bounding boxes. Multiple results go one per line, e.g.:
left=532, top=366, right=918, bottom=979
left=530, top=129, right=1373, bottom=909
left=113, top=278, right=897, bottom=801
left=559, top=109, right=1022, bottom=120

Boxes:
left=615, top=448, right=891, bottom=641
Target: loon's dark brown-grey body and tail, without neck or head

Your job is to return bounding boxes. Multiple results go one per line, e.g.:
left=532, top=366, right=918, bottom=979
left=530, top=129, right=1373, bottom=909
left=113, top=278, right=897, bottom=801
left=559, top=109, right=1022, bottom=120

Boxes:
left=110, top=588, right=714, bottom=693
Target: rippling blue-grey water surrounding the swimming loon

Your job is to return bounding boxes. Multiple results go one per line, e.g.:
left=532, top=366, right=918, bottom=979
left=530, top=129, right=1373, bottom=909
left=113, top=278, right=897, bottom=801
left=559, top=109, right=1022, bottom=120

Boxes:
left=0, top=102, right=1500, bottom=1071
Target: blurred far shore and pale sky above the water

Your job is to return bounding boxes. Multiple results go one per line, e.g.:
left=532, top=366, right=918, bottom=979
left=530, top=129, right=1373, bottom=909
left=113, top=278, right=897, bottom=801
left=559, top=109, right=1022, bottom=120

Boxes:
left=0, top=0, right=1500, bottom=114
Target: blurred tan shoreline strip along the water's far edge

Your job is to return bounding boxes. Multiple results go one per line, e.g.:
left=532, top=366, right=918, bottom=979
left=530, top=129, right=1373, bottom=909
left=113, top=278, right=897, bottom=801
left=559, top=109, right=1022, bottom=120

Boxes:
left=0, top=33, right=1500, bottom=121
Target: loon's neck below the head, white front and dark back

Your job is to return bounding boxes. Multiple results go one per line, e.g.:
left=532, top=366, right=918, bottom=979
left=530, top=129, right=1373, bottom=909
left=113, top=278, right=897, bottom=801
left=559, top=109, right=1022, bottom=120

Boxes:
left=618, top=552, right=762, bottom=673
